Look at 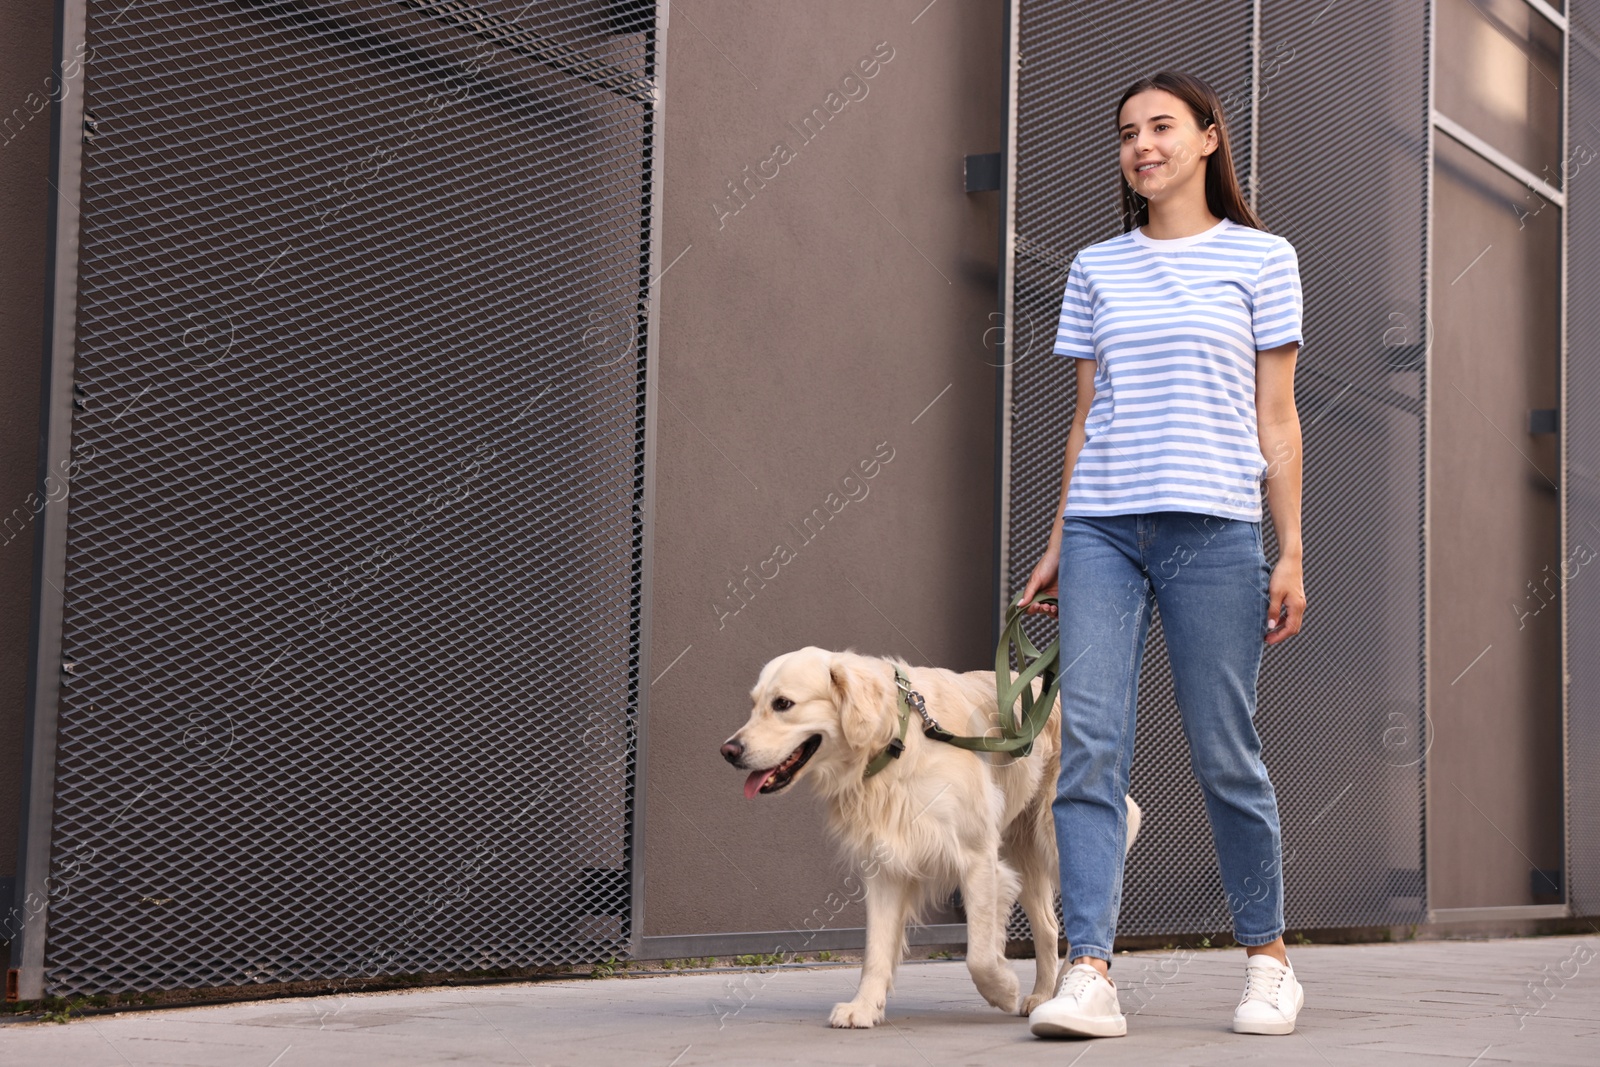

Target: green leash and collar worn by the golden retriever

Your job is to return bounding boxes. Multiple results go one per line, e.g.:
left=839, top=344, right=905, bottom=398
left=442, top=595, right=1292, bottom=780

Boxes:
left=862, top=592, right=1061, bottom=777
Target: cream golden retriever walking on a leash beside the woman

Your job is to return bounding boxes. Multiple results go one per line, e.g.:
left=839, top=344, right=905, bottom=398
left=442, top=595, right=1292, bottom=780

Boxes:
left=722, top=646, right=1139, bottom=1027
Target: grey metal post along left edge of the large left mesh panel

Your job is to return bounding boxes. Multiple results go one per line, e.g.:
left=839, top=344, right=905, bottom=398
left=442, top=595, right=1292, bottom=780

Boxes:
left=6, top=0, right=86, bottom=1000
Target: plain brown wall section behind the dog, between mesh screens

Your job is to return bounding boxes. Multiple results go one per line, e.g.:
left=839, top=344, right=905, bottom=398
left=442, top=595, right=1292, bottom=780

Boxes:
left=643, top=0, right=1005, bottom=936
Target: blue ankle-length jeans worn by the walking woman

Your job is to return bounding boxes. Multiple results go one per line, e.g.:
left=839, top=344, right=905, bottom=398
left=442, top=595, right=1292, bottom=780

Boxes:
left=1051, top=512, right=1283, bottom=961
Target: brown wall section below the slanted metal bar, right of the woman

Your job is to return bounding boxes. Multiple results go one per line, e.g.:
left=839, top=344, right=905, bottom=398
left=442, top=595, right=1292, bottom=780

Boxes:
left=1427, top=127, right=1561, bottom=909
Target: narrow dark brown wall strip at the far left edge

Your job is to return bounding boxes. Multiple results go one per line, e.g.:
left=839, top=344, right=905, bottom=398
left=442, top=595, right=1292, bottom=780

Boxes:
left=0, top=0, right=55, bottom=907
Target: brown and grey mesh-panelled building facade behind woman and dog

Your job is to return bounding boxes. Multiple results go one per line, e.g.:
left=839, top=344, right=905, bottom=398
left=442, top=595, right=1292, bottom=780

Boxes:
left=0, top=0, right=1600, bottom=1000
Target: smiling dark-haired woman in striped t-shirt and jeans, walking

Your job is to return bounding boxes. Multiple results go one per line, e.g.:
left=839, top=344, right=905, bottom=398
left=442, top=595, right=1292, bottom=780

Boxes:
left=1022, top=72, right=1306, bottom=1037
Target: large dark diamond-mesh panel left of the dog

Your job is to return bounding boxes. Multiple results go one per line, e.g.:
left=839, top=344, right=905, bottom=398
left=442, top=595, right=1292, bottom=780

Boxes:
left=45, top=0, right=656, bottom=995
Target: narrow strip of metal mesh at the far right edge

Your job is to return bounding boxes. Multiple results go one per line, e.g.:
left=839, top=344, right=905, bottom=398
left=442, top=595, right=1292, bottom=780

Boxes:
left=1560, top=8, right=1600, bottom=915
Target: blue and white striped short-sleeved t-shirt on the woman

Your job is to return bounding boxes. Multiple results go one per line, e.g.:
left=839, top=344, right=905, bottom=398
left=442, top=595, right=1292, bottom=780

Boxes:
left=1054, top=218, right=1302, bottom=522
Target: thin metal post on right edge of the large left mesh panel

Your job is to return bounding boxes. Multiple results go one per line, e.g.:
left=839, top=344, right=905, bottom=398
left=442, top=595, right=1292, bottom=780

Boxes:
left=627, top=0, right=672, bottom=960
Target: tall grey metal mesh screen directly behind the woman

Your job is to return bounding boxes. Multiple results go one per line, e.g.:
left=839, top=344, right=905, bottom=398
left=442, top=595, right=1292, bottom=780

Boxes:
left=1005, top=0, right=1427, bottom=939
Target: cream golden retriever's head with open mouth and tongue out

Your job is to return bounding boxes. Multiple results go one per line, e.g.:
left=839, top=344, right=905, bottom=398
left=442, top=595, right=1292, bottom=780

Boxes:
left=722, top=646, right=896, bottom=797
